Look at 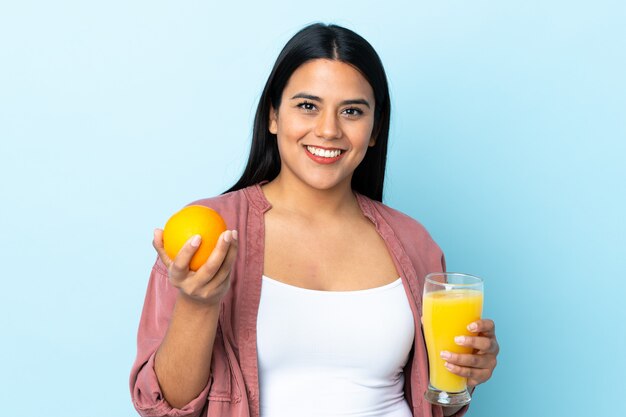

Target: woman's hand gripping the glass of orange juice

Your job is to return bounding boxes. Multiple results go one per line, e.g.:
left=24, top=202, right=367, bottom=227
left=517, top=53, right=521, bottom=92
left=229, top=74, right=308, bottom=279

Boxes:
left=441, top=319, right=500, bottom=388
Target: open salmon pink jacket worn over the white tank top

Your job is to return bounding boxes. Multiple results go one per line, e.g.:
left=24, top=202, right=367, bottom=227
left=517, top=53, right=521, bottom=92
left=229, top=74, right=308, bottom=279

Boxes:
left=130, top=184, right=467, bottom=417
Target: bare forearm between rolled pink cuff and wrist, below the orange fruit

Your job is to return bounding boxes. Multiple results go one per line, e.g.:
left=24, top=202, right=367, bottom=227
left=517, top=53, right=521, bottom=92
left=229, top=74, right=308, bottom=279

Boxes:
left=154, top=294, right=220, bottom=408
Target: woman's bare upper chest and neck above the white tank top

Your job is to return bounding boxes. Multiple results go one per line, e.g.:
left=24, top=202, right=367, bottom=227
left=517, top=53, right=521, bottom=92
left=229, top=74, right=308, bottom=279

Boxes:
left=264, top=181, right=399, bottom=291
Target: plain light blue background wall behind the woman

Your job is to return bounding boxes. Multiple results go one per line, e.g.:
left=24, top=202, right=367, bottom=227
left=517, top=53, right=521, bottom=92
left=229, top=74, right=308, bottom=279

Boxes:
left=0, top=0, right=626, bottom=417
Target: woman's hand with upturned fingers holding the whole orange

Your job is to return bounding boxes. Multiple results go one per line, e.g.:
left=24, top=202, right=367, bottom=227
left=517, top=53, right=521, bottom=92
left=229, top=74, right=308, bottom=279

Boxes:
left=152, top=229, right=238, bottom=306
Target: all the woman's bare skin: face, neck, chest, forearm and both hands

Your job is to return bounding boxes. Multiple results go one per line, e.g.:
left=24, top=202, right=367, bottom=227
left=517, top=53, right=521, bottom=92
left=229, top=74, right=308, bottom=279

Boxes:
left=147, top=59, right=497, bottom=415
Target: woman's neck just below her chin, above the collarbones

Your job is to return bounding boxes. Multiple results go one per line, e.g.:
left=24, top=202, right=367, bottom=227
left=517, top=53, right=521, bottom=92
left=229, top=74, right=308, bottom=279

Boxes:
left=263, top=175, right=360, bottom=218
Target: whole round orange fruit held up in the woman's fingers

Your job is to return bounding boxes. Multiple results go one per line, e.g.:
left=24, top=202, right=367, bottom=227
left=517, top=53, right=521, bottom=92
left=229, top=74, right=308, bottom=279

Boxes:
left=163, top=205, right=226, bottom=271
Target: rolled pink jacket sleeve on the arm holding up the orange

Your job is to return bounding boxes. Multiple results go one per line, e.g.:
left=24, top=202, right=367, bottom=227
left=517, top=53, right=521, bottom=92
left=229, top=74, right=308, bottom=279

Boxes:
left=130, top=259, right=212, bottom=417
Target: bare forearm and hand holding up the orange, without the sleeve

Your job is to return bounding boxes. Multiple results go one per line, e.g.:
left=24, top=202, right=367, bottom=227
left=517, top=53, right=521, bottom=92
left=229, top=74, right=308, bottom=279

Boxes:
left=153, top=229, right=237, bottom=408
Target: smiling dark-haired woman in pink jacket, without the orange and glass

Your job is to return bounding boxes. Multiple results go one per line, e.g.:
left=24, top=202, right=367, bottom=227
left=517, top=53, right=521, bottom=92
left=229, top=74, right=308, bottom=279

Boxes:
left=130, top=24, right=498, bottom=417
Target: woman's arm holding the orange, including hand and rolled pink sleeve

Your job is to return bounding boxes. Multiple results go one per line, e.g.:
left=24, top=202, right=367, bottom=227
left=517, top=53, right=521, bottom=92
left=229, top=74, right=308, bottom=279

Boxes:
left=131, top=229, right=237, bottom=416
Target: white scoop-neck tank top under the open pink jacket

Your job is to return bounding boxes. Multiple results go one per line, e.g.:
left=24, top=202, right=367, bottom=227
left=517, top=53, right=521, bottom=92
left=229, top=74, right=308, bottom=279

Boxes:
left=257, top=276, right=415, bottom=417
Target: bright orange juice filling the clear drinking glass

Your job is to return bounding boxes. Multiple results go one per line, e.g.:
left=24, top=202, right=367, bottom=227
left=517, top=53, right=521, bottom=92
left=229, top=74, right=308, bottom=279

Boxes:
left=422, top=289, right=483, bottom=392
